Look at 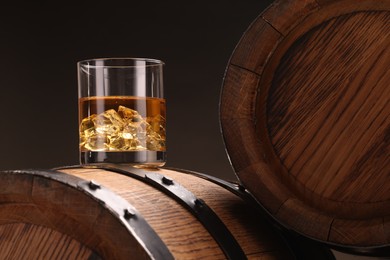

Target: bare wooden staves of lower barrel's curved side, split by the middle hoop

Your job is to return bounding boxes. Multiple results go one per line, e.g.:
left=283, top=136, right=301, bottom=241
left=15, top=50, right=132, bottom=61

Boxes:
left=64, top=169, right=291, bottom=259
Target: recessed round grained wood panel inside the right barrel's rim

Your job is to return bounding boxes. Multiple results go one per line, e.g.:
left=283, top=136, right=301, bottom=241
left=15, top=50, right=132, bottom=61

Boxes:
left=266, top=12, right=390, bottom=214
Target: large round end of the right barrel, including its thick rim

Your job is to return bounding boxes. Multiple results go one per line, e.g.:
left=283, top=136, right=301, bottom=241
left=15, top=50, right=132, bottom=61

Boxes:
left=220, top=0, right=390, bottom=250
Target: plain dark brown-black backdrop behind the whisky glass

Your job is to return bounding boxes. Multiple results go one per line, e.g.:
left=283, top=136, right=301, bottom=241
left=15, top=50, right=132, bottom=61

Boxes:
left=0, top=0, right=271, bottom=179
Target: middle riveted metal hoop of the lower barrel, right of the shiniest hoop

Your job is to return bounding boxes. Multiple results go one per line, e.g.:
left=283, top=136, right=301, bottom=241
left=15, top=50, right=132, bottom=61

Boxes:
left=56, top=163, right=247, bottom=260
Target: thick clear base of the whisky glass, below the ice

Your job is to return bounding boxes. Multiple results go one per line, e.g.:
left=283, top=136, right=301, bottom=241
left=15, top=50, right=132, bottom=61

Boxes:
left=80, top=151, right=166, bottom=168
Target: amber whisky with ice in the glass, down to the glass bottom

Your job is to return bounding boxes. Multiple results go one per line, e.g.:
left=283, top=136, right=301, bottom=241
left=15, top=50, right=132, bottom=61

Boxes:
left=79, top=96, right=166, bottom=167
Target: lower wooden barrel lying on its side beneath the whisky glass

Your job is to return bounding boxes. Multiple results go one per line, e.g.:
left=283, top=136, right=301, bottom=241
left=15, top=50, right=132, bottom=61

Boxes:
left=0, top=165, right=334, bottom=259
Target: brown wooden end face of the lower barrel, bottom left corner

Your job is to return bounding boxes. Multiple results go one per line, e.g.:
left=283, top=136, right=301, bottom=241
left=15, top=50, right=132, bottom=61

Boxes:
left=0, top=173, right=149, bottom=259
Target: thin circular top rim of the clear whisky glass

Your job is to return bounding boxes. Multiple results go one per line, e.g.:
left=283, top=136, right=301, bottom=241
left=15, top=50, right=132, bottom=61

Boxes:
left=77, top=57, right=165, bottom=68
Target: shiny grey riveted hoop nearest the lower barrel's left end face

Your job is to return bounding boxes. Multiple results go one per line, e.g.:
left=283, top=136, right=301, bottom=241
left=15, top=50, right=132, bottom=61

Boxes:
left=14, top=170, right=174, bottom=259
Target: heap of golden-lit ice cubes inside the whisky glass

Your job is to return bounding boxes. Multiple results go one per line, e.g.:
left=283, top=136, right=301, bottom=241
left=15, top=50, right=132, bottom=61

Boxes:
left=80, top=106, right=165, bottom=151
